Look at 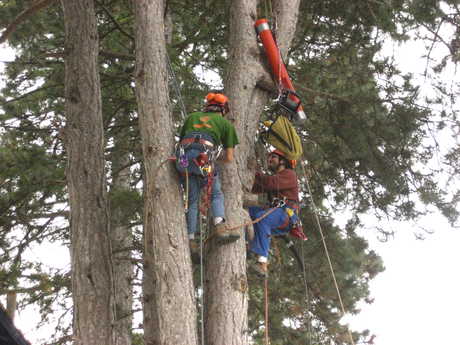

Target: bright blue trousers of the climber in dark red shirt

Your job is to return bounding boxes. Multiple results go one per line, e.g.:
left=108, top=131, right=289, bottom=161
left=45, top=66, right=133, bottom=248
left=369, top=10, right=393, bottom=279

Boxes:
left=249, top=206, right=289, bottom=258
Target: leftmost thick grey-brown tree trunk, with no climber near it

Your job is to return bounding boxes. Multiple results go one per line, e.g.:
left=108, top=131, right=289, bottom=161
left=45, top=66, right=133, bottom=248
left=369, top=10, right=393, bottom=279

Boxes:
left=62, top=0, right=115, bottom=345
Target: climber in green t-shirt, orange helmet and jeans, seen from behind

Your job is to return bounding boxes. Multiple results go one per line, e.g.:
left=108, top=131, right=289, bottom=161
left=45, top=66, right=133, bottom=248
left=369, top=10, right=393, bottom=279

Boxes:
left=176, top=93, right=240, bottom=255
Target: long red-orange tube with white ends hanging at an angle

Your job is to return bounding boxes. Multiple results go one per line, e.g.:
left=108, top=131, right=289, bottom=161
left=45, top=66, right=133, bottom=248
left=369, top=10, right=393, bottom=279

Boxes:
left=254, top=18, right=307, bottom=124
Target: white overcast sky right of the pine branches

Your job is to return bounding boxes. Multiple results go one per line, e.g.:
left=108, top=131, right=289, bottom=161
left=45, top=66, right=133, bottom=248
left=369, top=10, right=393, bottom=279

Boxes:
left=351, top=28, right=460, bottom=345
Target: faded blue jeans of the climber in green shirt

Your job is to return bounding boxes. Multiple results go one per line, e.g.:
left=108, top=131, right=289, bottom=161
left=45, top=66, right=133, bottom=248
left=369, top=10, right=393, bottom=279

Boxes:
left=181, top=174, right=225, bottom=234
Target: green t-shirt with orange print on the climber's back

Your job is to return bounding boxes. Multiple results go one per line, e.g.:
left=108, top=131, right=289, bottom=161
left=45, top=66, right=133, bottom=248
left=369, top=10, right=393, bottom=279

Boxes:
left=180, top=112, right=239, bottom=148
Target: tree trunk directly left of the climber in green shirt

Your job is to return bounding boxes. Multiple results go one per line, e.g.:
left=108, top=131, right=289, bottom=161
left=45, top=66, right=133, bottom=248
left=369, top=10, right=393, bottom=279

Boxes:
left=135, top=0, right=197, bottom=345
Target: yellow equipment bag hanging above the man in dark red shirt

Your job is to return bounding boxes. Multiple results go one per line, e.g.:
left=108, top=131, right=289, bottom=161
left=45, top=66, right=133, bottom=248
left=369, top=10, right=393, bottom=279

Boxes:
left=261, top=116, right=303, bottom=160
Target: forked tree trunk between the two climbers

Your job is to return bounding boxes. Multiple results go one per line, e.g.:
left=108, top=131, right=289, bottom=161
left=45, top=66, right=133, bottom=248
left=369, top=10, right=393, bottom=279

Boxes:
left=205, top=0, right=299, bottom=345
